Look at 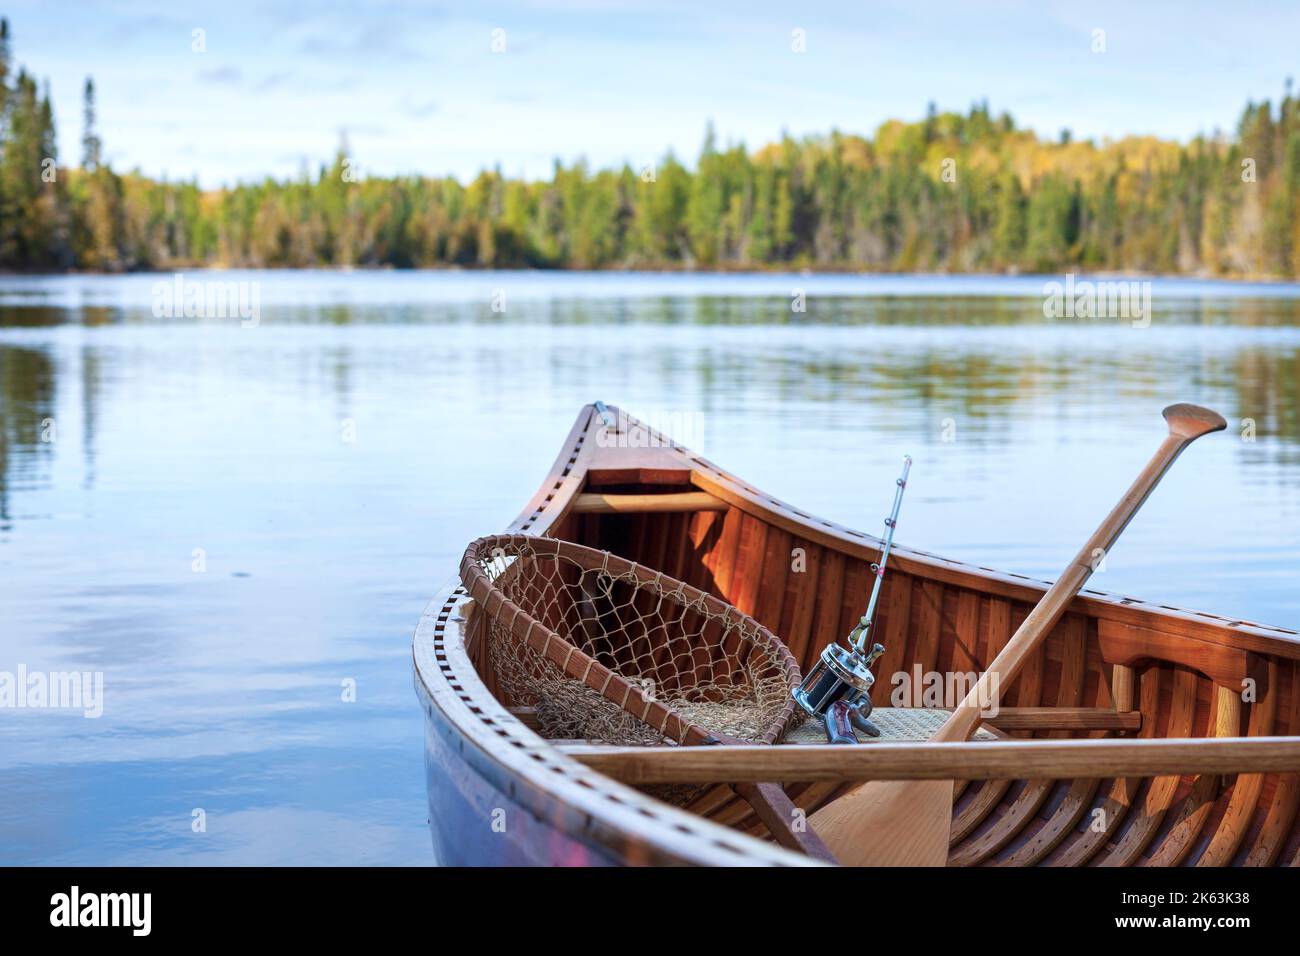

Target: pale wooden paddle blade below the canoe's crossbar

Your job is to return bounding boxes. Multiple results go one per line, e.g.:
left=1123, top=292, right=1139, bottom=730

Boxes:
left=809, top=780, right=953, bottom=866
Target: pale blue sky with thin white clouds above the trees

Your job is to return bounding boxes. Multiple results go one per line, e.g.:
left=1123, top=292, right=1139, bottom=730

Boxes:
left=0, top=0, right=1300, bottom=186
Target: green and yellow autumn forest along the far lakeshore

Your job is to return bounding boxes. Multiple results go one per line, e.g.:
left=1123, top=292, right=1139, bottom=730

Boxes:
left=0, top=22, right=1300, bottom=278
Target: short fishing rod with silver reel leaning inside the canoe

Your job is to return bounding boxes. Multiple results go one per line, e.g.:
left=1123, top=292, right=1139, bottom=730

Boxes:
left=792, top=455, right=911, bottom=744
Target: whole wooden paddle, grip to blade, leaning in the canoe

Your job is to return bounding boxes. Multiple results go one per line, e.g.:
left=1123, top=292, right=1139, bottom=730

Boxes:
left=809, top=405, right=1227, bottom=866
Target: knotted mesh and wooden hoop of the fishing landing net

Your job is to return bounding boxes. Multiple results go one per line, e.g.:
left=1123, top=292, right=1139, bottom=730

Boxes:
left=462, top=535, right=800, bottom=744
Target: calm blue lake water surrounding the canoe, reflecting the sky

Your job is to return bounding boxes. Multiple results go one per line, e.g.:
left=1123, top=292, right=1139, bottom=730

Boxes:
left=0, top=272, right=1300, bottom=865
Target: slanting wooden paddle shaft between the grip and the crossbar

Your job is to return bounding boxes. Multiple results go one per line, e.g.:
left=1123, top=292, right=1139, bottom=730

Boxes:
left=931, top=432, right=1196, bottom=743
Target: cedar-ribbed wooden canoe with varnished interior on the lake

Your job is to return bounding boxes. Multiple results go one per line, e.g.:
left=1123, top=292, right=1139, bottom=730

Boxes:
left=413, top=406, right=1300, bottom=866
